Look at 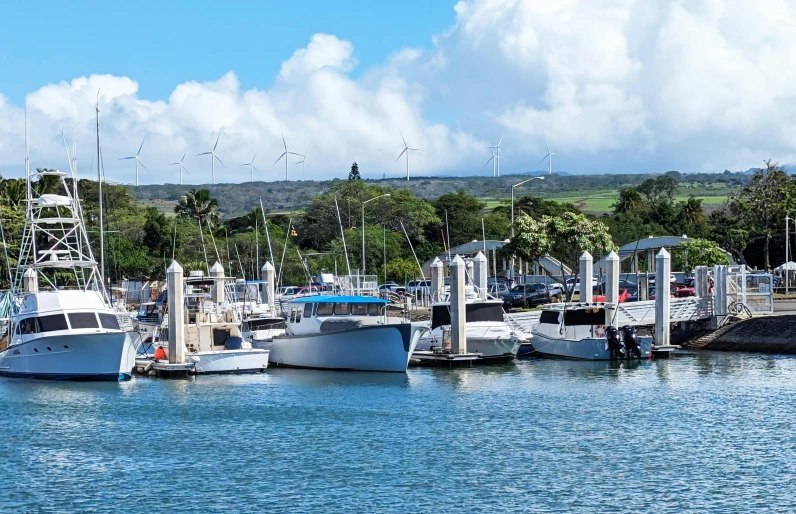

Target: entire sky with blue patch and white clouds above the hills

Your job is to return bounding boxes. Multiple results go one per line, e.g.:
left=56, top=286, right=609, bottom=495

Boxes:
left=0, top=0, right=796, bottom=184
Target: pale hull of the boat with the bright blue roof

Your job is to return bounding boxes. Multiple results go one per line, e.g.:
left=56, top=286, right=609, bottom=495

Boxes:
left=260, top=323, right=425, bottom=373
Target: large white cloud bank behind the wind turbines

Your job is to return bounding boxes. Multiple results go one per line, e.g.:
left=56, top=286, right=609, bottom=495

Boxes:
left=0, top=0, right=796, bottom=182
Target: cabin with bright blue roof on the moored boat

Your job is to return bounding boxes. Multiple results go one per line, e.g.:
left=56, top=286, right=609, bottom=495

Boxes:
left=286, top=295, right=387, bottom=335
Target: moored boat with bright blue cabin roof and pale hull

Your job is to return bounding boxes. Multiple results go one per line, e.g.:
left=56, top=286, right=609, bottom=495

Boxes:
left=254, top=295, right=428, bottom=373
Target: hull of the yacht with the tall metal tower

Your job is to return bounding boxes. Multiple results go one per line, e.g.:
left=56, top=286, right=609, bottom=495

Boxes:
left=0, top=332, right=136, bottom=380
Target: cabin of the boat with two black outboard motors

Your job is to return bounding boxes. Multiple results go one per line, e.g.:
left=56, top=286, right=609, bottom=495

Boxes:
left=533, top=302, right=605, bottom=341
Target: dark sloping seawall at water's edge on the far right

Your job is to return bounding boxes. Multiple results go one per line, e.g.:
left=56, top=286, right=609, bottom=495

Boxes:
left=683, top=314, right=796, bottom=354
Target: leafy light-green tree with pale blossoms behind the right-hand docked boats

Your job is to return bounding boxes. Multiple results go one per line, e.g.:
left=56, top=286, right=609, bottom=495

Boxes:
left=503, top=212, right=617, bottom=301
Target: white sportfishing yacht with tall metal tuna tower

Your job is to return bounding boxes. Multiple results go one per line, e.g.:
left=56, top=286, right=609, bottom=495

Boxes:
left=0, top=171, right=135, bottom=380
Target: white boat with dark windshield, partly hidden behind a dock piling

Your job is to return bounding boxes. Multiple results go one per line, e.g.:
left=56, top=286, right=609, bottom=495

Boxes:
left=416, top=285, right=523, bottom=364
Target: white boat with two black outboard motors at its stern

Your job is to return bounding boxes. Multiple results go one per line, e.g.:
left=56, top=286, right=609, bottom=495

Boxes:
left=531, top=302, right=652, bottom=360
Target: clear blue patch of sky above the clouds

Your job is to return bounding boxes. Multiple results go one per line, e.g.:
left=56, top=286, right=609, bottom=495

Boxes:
left=0, top=0, right=455, bottom=103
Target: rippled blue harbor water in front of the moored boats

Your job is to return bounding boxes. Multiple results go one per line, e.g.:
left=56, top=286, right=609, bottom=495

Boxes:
left=0, top=352, right=796, bottom=512
